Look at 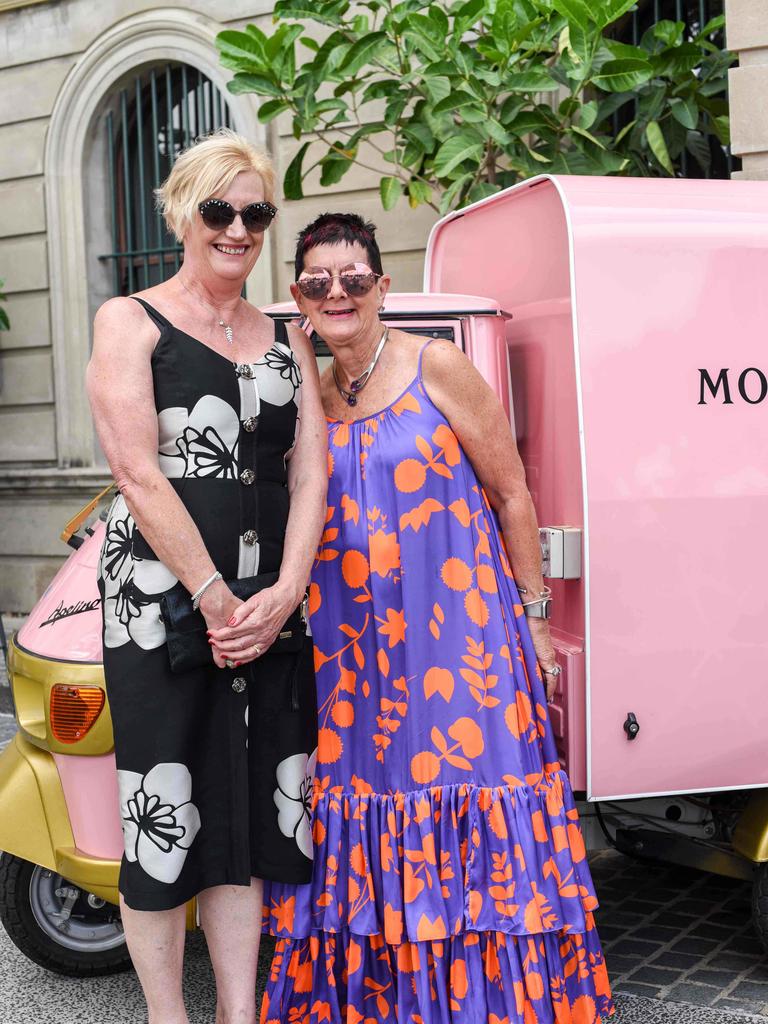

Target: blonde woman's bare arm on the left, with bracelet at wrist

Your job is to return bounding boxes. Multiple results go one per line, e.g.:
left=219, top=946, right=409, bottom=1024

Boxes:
left=86, top=298, right=240, bottom=655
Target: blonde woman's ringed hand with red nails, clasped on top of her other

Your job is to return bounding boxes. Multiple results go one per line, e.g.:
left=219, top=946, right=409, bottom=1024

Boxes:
left=201, top=582, right=301, bottom=665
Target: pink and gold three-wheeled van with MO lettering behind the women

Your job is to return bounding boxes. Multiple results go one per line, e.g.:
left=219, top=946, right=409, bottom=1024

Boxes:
left=0, top=175, right=768, bottom=973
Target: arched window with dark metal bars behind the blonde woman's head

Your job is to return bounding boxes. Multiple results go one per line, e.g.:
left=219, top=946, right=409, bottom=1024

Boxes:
left=99, top=63, right=231, bottom=295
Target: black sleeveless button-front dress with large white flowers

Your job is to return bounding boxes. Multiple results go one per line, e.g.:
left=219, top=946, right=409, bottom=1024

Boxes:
left=99, top=299, right=316, bottom=910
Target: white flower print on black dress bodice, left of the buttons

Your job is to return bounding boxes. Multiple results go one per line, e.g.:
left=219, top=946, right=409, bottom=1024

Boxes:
left=158, top=394, right=240, bottom=479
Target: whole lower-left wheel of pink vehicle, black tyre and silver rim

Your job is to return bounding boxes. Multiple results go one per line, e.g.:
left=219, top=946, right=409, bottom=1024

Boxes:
left=0, top=853, right=131, bottom=978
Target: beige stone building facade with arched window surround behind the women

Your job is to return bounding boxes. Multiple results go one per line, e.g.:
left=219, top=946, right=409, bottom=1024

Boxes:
left=0, top=0, right=768, bottom=612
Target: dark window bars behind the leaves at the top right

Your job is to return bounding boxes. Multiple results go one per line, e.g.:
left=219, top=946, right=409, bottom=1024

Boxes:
left=613, top=0, right=740, bottom=178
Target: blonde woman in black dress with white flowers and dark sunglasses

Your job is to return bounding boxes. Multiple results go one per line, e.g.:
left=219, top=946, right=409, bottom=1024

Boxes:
left=87, top=130, right=327, bottom=1024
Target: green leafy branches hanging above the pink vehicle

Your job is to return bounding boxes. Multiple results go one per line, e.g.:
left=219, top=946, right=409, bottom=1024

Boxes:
left=217, top=0, right=734, bottom=212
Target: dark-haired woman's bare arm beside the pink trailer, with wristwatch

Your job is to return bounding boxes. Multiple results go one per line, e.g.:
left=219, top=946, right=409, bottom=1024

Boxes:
left=423, top=340, right=555, bottom=691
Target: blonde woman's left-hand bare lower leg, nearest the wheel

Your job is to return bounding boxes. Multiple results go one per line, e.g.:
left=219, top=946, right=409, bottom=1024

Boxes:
left=120, top=896, right=188, bottom=1024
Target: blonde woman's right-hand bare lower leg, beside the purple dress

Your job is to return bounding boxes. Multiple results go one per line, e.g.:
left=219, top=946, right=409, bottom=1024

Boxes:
left=198, top=879, right=263, bottom=1024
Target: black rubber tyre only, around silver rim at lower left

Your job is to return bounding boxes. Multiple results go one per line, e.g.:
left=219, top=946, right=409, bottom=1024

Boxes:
left=0, top=853, right=132, bottom=978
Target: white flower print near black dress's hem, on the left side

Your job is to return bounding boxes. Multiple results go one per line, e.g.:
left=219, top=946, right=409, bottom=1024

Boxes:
left=118, top=763, right=201, bottom=884
